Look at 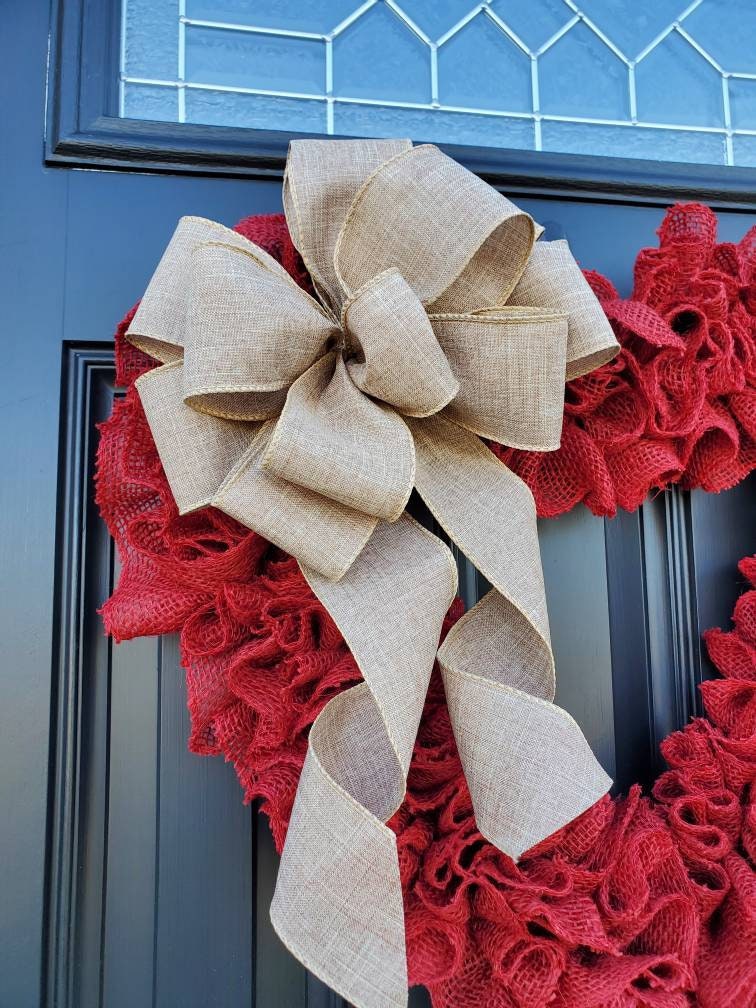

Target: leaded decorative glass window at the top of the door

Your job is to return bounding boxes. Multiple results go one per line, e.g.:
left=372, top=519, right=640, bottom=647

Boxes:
left=120, top=0, right=756, bottom=165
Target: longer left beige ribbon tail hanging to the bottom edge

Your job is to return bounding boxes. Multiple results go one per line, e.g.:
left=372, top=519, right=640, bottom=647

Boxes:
left=270, top=516, right=457, bottom=1008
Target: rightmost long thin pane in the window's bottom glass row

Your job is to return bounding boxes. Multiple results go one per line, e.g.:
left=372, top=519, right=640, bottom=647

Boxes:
left=541, top=122, right=727, bottom=164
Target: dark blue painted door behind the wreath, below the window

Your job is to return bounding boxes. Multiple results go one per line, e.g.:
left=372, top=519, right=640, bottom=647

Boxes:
left=0, top=0, right=756, bottom=1008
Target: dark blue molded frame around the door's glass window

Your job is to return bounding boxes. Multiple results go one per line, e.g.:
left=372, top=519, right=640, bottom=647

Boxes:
left=44, top=0, right=756, bottom=211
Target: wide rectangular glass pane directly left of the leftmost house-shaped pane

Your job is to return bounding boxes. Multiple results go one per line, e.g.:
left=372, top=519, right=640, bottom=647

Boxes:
left=185, top=25, right=326, bottom=95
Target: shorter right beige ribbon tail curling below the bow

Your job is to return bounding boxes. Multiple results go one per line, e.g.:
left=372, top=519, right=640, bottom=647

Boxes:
left=408, top=416, right=611, bottom=859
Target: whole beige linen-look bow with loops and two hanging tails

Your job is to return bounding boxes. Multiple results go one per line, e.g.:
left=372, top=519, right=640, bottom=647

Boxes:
left=128, top=140, right=618, bottom=1008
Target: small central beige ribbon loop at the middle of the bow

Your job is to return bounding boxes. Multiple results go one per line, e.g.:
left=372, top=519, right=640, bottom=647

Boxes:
left=342, top=268, right=460, bottom=416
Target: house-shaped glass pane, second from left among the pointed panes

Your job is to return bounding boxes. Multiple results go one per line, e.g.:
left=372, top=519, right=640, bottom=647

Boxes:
left=438, top=13, right=533, bottom=112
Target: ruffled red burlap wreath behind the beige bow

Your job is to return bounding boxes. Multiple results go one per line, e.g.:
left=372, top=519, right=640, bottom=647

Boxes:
left=97, top=208, right=756, bottom=1008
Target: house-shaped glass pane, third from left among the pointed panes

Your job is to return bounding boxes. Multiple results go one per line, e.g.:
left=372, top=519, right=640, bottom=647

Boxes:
left=538, top=24, right=629, bottom=119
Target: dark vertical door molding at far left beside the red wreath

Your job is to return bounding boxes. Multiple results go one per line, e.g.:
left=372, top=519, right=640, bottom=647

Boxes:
left=42, top=344, right=115, bottom=1008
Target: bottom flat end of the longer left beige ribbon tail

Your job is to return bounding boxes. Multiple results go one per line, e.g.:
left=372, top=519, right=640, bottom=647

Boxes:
left=270, top=747, right=407, bottom=1008
